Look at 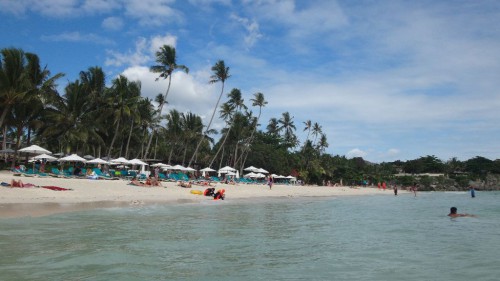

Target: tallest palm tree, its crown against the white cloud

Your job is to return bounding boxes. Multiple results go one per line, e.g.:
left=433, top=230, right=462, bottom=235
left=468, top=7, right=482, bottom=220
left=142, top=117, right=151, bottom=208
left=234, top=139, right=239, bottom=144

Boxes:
left=148, top=45, right=189, bottom=158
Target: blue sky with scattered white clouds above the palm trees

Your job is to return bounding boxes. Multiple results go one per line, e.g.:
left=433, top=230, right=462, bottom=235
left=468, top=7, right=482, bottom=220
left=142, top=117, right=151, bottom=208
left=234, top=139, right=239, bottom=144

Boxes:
left=0, top=0, right=500, bottom=163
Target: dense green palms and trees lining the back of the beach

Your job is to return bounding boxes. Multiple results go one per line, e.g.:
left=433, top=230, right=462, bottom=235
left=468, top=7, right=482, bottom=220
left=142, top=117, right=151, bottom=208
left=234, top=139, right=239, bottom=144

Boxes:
left=0, top=45, right=500, bottom=190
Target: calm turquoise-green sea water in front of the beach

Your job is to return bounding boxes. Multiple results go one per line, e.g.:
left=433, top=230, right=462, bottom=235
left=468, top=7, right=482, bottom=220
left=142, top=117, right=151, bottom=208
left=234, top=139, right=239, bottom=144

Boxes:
left=0, top=192, right=500, bottom=281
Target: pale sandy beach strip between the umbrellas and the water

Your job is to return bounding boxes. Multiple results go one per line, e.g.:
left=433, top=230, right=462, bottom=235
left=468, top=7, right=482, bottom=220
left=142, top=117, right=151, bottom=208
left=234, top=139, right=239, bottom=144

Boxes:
left=0, top=171, right=405, bottom=217
